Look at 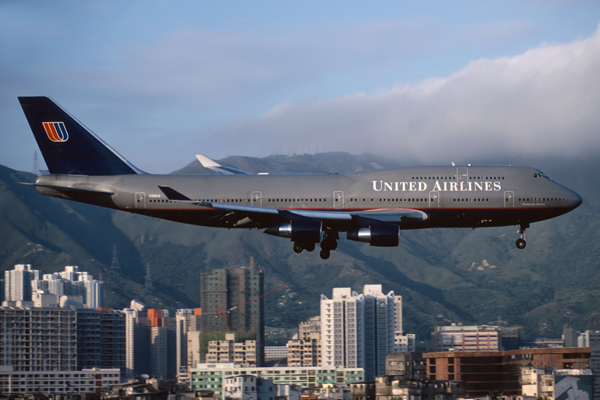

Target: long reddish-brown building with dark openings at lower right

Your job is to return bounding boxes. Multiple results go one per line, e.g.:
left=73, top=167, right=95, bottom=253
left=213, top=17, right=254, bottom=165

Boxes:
left=423, top=347, right=592, bottom=396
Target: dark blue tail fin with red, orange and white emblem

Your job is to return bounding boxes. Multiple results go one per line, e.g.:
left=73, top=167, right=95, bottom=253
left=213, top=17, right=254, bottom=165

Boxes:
left=19, top=97, right=141, bottom=175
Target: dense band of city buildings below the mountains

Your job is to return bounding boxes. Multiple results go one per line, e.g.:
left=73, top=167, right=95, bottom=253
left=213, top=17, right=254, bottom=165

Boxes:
left=0, top=264, right=600, bottom=400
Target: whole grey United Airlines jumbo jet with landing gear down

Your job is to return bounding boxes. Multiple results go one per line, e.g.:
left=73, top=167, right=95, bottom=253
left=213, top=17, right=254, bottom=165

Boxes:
left=19, top=97, right=582, bottom=259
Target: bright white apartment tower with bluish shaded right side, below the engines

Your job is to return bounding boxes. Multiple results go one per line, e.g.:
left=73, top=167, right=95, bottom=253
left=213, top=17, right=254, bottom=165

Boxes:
left=321, top=285, right=396, bottom=381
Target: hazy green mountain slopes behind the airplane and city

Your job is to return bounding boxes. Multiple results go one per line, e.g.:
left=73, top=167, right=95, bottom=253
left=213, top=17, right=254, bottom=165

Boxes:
left=0, top=153, right=600, bottom=342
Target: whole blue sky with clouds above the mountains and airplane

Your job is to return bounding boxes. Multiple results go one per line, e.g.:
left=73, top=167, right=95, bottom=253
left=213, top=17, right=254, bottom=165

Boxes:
left=0, top=0, right=600, bottom=173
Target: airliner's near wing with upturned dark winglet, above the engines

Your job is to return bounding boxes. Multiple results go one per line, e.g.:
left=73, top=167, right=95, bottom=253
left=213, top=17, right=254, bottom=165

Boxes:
left=159, top=185, right=429, bottom=226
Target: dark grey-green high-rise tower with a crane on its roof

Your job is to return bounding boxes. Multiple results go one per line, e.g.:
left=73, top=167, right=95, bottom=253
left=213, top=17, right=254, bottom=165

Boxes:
left=200, top=268, right=265, bottom=365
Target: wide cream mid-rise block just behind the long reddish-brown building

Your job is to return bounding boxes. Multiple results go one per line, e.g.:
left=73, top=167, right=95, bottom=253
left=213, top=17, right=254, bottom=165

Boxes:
left=431, top=324, right=502, bottom=352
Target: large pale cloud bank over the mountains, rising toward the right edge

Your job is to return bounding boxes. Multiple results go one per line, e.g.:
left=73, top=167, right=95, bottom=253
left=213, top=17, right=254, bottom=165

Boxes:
left=209, top=22, right=600, bottom=163
